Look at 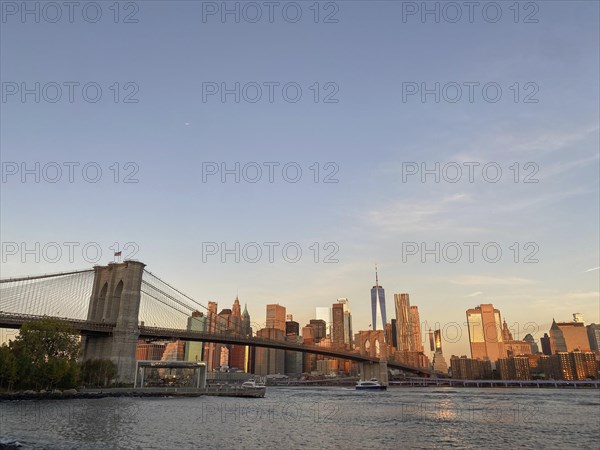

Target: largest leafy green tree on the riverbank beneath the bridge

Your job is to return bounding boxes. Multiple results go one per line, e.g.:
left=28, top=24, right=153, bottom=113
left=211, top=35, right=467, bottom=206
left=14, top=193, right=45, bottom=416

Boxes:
left=10, top=319, right=79, bottom=389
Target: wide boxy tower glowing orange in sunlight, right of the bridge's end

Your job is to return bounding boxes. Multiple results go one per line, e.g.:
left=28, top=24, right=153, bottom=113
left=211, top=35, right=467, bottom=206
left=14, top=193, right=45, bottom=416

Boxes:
left=467, top=304, right=504, bottom=362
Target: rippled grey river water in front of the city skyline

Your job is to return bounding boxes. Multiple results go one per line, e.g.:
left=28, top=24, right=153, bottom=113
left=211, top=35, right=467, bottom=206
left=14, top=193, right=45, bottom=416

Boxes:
left=0, top=387, right=600, bottom=449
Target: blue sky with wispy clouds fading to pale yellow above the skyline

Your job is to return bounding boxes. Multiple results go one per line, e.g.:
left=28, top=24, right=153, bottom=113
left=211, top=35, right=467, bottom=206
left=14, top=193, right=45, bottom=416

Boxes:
left=0, top=1, right=600, bottom=357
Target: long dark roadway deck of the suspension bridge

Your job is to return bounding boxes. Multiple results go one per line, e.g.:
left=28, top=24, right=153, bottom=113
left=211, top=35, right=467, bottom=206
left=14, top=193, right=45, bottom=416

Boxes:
left=0, top=311, right=432, bottom=377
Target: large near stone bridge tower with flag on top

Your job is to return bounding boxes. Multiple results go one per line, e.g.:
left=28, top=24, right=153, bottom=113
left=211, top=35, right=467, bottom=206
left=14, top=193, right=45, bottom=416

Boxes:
left=83, top=261, right=145, bottom=383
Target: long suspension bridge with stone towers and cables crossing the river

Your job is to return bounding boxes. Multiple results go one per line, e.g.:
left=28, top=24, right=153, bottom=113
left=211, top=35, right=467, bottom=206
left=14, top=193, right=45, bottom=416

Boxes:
left=0, top=260, right=434, bottom=383
